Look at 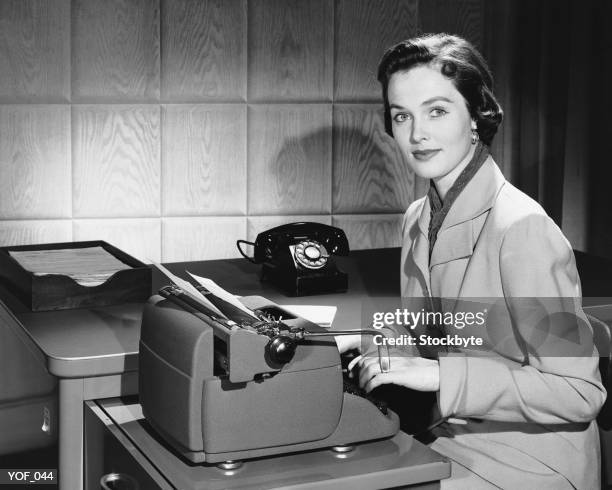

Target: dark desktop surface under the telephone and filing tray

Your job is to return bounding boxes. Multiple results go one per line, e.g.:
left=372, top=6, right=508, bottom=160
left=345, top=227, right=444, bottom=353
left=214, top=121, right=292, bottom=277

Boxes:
left=0, top=249, right=399, bottom=378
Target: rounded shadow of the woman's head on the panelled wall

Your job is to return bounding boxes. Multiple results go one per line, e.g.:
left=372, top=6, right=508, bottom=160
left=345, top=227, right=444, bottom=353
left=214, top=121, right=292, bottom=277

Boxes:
left=264, top=126, right=414, bottom=218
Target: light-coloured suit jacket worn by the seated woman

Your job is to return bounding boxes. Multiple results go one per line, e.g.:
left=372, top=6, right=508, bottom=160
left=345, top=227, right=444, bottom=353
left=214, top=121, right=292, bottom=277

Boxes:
left=401, top=157, right=606, bottom=489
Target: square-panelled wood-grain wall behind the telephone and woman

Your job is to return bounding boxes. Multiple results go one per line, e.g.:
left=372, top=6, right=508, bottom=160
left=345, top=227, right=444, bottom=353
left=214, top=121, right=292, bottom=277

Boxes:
left=0, top=0, right=483, bottom=261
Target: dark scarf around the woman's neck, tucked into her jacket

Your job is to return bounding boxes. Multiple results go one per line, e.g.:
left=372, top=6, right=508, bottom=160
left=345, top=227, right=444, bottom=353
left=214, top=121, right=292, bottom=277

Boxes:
left=427, top=142, right=489, bottom=260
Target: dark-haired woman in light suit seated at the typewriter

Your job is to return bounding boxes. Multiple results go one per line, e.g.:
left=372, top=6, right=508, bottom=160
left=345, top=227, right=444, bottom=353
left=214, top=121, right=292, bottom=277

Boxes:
left=338, top=34, right=605, bottom=489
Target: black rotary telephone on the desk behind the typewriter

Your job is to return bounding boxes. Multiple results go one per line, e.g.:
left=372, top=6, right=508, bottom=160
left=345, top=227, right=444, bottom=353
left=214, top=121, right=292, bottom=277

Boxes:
left=236, top=222, right=349, bottom=296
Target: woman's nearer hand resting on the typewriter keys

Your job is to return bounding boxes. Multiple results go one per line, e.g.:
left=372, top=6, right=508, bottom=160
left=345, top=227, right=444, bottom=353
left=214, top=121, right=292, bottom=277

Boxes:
left=349, top=356, right=440, bottom=392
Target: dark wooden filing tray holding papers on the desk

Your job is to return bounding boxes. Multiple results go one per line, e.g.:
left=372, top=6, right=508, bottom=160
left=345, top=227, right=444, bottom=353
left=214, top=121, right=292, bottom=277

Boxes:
left=0, top=240, right=151, bottom=311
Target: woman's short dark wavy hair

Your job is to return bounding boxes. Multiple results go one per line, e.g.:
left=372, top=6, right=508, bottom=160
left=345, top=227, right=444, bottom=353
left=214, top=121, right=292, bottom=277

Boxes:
left=378, top=34, right=503, bottom=145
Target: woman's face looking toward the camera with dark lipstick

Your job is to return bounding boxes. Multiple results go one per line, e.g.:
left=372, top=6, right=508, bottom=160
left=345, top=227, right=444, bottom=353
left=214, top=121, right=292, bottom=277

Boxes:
left=387, top=65, right=475, bottom=197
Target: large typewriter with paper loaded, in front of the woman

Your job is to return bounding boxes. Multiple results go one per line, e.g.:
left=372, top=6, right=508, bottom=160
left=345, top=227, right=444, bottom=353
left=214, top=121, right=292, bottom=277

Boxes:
left=139, top=286, right=399, bottom=469
